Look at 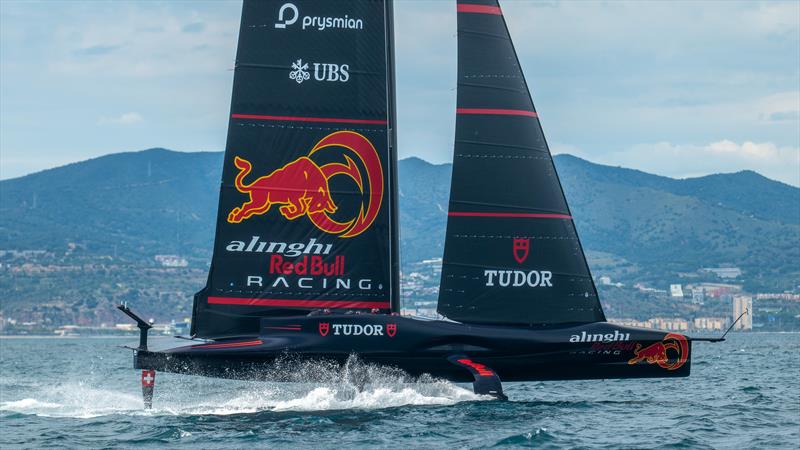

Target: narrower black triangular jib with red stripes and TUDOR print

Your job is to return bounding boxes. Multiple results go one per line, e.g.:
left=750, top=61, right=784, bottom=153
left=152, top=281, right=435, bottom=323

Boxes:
left=438, top=0, right=605, bottom=326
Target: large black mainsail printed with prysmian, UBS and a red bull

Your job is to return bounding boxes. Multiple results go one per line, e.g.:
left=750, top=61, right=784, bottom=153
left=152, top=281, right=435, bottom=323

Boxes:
left=192, top=0, right=399, bottom=337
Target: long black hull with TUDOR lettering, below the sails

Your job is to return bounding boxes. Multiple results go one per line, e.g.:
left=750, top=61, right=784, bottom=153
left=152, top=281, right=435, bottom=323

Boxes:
left=128, top=314, right=691, bottom=382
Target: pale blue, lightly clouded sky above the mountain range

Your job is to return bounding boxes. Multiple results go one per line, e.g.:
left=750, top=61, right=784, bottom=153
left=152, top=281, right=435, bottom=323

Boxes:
left=0, top=0, right=800, bottom=186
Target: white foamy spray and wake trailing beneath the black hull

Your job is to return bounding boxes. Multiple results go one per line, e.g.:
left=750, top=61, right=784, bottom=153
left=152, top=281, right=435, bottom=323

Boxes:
left=0, top=358, right=484, bottom=418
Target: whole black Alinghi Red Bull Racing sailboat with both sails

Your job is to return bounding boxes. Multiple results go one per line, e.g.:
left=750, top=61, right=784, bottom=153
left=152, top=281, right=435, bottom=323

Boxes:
left=120, top=0, right=724, bottom=404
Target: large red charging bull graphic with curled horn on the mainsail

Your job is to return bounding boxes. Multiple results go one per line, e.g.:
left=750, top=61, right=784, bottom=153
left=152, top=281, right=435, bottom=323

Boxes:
left=228, top=131, right=383, bottom=238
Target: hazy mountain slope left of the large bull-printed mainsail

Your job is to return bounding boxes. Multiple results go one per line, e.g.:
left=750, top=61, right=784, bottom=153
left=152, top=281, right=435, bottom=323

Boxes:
left=0, top=149, right=222, bottom=259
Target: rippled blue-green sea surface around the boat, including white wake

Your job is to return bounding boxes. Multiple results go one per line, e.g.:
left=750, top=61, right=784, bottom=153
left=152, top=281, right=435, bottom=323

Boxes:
left=0, top=333, right=800, bottom=449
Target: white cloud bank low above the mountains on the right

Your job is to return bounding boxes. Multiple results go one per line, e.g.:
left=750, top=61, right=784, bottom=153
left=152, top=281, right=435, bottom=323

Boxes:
left=594, top=139, right=800, bottom=186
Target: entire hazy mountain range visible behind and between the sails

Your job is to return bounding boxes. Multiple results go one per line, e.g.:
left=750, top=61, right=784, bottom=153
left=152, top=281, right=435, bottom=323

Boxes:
left=0, top=149, right=800, bottom=312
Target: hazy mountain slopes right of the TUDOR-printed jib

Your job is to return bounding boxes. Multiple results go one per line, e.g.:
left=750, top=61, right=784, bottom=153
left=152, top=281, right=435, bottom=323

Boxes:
left=556, top=155, right=800, bottom=291
